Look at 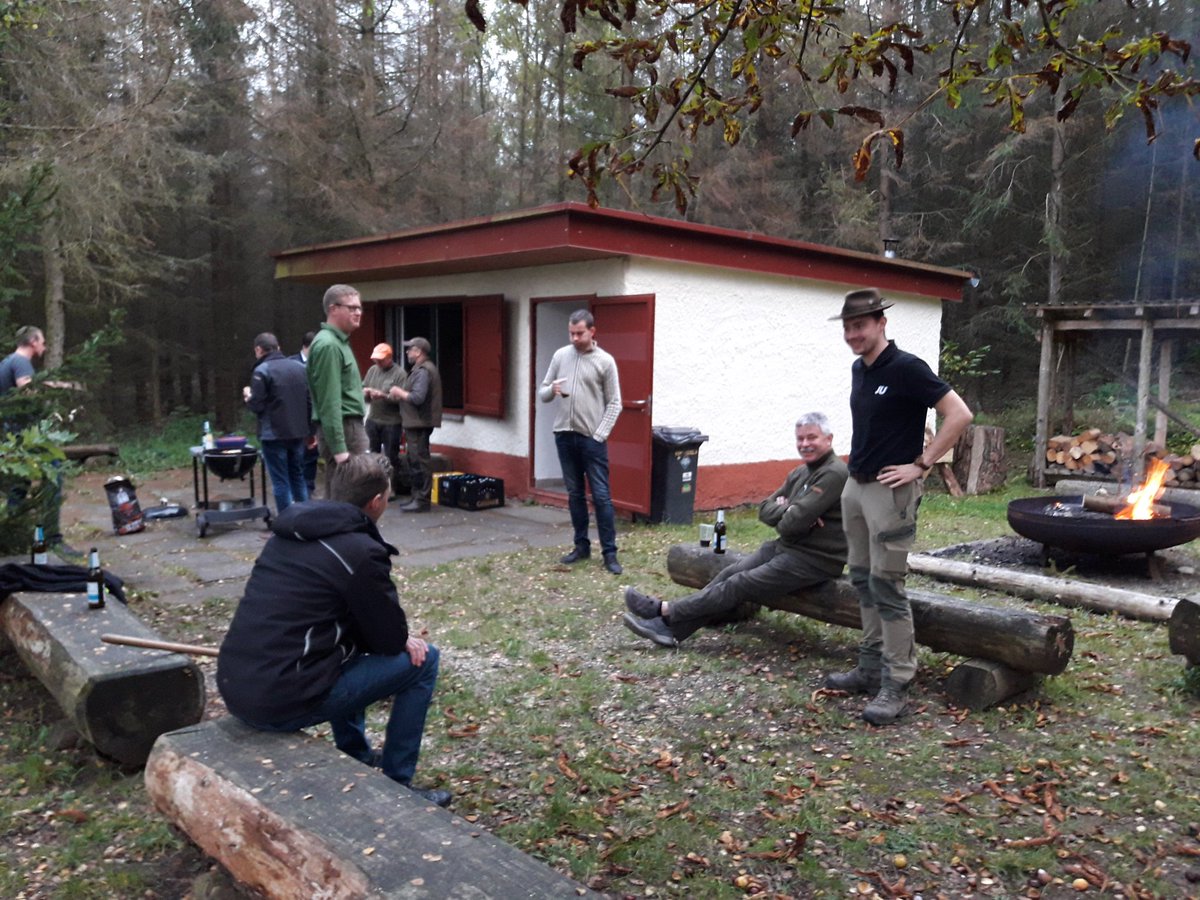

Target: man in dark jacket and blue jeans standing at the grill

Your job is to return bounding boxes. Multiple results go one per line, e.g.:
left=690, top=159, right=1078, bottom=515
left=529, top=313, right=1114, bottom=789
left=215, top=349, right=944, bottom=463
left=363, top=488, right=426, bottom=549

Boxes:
left=241, top=331, right=311, bottom=512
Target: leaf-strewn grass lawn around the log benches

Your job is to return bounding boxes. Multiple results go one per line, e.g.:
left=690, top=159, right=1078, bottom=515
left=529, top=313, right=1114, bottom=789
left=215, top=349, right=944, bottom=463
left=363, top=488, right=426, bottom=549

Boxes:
left=0, top=475, right=1200, bottom=898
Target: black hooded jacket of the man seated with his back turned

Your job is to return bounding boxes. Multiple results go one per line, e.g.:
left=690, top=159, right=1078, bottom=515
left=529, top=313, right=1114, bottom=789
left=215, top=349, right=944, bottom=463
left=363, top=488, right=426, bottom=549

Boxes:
left=217, top=500, right=408, bottom=725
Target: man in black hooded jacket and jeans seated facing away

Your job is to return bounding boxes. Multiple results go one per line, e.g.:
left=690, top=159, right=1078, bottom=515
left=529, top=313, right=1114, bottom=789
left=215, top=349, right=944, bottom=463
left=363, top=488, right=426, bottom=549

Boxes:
left=217, top=454, right=450, bottom=806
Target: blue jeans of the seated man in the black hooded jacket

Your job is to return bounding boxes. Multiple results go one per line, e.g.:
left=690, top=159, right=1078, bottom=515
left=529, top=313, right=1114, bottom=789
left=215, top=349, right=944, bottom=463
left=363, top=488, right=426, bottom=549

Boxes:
left=238, top=644, right=438, bottom=785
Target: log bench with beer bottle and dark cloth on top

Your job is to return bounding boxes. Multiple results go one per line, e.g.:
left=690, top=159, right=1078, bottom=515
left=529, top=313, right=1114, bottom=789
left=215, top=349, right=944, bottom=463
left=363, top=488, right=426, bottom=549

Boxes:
left=0, top=593, right=204, bottom=766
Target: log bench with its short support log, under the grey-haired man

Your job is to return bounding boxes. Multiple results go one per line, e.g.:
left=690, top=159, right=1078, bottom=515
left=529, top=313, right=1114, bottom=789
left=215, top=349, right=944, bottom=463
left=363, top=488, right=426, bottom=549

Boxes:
left=667, top=544, right=1075, bottom=709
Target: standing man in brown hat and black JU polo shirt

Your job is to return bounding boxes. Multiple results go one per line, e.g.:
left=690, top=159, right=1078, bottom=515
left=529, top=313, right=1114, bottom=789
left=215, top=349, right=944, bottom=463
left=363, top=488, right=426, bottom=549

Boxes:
left=826, top=288, right=973, bottom=725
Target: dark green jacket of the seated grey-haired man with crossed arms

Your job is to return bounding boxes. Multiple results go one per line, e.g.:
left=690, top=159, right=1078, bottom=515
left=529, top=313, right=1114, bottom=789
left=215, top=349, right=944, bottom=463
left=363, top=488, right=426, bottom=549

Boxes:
left=758, top=451, right=848, bottom=577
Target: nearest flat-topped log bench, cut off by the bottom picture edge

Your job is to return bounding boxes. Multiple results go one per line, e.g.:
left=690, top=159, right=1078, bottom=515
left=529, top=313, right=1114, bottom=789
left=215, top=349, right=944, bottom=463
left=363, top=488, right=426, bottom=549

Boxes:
left=145, top=716, right=589, bottom=900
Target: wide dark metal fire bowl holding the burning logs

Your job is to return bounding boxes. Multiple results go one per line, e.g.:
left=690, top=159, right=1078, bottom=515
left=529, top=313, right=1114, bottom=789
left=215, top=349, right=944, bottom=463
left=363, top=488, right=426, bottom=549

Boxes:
left=1008, top=497, right=1200, bottom=556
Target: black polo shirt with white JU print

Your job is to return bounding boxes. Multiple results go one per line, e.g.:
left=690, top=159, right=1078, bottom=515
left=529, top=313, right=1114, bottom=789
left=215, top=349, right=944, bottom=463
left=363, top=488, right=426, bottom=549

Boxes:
left=848, top=341, right=950, bottom=475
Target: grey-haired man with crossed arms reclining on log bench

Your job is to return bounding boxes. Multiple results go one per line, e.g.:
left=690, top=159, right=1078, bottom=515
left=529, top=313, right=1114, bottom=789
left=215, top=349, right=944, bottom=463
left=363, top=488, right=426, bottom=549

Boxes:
left=624, top=413, right=847, bottom=647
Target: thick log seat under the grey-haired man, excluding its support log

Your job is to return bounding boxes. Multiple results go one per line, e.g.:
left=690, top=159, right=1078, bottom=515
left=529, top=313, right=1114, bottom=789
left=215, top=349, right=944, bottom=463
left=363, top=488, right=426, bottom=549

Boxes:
left=667, top=544, right=1075, bottom=674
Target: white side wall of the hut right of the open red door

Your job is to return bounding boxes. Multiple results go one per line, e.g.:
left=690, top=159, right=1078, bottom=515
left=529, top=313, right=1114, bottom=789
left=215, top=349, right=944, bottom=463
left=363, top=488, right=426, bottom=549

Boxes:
left=625, top=259, right=942, bottom=466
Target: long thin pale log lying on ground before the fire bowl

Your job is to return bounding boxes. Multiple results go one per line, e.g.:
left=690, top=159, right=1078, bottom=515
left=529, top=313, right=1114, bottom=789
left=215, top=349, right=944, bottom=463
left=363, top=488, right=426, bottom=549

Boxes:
left=908, top=553, right=1176, bottom=622
